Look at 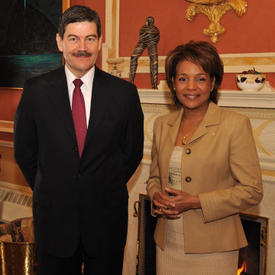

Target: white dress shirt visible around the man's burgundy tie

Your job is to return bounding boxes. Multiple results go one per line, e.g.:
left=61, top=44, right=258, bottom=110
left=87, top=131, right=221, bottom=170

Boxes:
left=65, top=65, right=95, bottom=128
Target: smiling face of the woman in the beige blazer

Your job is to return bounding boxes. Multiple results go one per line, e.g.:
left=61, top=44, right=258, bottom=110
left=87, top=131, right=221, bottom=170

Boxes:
left=173, top=60, right=215, bottom=111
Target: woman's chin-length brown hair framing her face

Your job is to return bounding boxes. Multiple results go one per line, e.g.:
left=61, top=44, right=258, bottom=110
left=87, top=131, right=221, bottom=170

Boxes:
left=165, top=41, right=223, bottom=105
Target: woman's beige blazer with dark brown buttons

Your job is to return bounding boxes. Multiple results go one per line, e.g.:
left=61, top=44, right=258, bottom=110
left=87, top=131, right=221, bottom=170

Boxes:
left=147, top=102, right=262, bottom=253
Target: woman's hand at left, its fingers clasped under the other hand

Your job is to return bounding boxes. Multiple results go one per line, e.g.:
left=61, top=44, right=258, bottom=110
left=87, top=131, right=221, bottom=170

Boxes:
left=153, top=192, right=181, bottom=219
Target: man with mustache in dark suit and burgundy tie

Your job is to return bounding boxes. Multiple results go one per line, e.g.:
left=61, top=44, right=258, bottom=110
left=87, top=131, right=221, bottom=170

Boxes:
left=14, top=6, right=143, bottom=275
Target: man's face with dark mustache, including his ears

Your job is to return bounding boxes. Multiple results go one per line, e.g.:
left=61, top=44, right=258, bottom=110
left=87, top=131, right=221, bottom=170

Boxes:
left=56, top=21, right=102, bottom=78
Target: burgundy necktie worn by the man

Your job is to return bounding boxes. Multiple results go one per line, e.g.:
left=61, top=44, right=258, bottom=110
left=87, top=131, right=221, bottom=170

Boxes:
left=72, top=79, right=87, bottom=157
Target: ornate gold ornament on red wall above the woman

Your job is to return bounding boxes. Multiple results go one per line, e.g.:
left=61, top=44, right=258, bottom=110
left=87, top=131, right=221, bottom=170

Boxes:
left=185, top=0, right=247, bottom=43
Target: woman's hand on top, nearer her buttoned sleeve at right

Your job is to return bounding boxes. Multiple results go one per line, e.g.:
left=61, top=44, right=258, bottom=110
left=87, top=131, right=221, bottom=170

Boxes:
left=165, top=187, right=201, bottom=214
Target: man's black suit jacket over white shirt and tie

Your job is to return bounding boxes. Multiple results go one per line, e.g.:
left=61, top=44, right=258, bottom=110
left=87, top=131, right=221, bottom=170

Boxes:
left=14, top=67, right=143, bottom=256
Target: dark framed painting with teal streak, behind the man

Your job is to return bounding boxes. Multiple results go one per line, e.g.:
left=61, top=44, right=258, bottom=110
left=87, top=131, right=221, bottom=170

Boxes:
left=0, top=0, right=70, bottom=88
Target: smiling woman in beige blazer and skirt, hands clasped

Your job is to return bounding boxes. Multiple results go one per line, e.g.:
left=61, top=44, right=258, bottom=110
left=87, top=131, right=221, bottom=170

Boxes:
left=147, top=41, right=262, bottom=275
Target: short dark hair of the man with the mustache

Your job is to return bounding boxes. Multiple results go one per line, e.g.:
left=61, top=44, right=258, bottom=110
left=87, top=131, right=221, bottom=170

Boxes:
left=58, top=5, right=101, bottom=39
